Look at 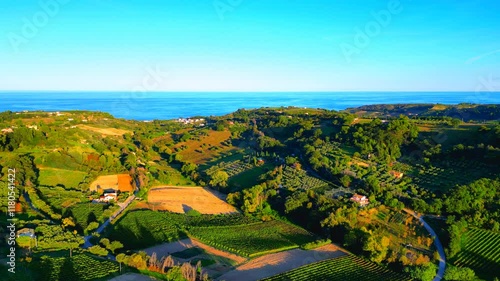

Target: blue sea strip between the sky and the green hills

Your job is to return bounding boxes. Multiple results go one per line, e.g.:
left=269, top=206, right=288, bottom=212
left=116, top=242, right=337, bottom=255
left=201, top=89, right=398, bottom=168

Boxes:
left=0, top=91, right=500, bottom=121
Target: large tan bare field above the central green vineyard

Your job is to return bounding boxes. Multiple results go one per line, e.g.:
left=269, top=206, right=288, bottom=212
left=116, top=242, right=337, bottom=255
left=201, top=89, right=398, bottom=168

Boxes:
left=148, top=186, right=237, bottom=214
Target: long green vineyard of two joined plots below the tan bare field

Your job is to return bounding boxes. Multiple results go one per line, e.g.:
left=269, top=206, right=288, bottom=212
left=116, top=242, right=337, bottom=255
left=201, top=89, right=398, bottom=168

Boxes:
left=109, top=210, right=316, bottom=256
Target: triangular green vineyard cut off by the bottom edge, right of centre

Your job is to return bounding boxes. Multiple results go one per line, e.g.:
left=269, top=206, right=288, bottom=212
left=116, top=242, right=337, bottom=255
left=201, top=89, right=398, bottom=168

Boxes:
left=263, top=255, right=411, bottom=281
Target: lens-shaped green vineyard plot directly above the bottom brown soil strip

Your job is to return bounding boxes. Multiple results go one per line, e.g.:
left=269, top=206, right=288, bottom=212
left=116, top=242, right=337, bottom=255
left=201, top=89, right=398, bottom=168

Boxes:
left=189, top=221, right=316, bottom=257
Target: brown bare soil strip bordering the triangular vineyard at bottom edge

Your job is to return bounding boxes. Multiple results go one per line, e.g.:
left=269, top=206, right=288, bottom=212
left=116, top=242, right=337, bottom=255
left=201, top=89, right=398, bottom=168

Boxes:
left=216, top=244, right=346, bottom=281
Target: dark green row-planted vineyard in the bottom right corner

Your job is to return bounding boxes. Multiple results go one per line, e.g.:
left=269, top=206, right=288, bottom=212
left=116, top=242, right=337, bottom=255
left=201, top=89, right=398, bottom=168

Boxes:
left=452, top=228, right=500, bottom=280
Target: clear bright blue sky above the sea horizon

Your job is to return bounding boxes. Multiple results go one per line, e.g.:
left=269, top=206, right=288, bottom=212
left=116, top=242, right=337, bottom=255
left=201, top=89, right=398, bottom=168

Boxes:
left=0, top=0, right=500, bottom=91
